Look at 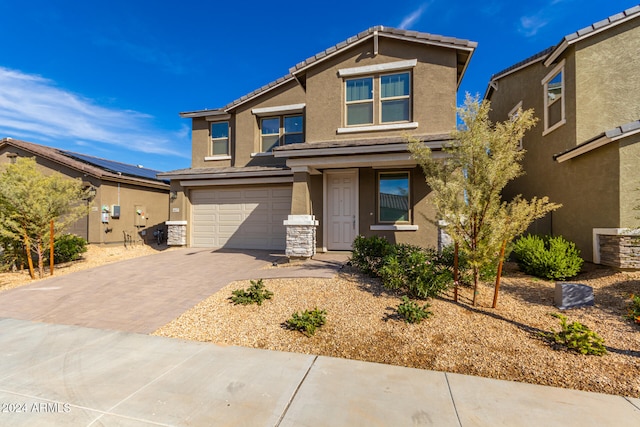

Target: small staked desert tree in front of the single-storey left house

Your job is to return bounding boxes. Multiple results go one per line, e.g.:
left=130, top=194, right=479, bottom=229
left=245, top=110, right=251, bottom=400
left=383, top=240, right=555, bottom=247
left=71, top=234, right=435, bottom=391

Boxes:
left=0, top=158, right=88, bottom=278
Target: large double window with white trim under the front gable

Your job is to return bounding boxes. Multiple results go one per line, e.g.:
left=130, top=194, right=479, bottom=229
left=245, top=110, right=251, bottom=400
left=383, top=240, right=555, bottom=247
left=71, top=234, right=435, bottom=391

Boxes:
left=345, top=72, right=411, bottom=126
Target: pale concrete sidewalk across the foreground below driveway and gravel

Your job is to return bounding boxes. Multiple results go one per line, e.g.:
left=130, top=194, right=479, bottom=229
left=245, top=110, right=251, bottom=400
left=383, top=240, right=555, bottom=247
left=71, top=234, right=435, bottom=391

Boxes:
left=0, top=319, right=640, bottom=427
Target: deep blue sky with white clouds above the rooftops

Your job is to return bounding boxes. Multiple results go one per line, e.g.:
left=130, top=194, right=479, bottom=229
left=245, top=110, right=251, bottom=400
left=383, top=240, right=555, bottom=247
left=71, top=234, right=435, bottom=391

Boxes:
left=0, top=0, right=637, bottom=170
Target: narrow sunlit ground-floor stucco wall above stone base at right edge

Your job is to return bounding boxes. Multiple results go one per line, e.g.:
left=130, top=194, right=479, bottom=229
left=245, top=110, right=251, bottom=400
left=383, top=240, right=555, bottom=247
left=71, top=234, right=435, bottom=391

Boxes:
left=620, top=134, right=640, bottom=228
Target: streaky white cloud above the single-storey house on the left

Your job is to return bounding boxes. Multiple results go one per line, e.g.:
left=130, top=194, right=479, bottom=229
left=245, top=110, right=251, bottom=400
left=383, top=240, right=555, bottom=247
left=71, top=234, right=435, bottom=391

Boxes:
left=0, top=67, right=188, bottom=157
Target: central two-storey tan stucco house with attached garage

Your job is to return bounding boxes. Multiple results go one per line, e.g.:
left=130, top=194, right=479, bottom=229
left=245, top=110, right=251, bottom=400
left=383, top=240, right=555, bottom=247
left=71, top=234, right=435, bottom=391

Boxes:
left=160, top=26, right=476, bottom=257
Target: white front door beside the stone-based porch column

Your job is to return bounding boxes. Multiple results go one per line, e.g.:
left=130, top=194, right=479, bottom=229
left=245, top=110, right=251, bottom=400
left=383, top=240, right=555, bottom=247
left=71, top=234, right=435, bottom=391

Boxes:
left=325, top=170, right=358, bottom=250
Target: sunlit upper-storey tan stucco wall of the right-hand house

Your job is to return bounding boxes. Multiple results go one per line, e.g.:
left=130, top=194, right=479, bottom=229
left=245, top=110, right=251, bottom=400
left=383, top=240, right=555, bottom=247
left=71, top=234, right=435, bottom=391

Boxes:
left=575, top=19, right=640, bottom=142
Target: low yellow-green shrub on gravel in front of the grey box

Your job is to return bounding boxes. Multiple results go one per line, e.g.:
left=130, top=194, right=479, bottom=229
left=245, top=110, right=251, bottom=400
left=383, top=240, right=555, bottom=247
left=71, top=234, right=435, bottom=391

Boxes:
left=541, top=313, right=607, bottom=356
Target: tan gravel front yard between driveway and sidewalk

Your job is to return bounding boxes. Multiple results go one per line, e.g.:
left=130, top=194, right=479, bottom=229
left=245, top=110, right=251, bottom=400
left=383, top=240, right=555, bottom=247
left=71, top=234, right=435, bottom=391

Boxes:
left=154, top=264, right=640, bottom=398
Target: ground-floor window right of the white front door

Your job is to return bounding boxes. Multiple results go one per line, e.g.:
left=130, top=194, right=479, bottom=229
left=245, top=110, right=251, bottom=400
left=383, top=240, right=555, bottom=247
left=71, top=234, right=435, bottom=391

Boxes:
left=378, top=172, right=410, bottom=224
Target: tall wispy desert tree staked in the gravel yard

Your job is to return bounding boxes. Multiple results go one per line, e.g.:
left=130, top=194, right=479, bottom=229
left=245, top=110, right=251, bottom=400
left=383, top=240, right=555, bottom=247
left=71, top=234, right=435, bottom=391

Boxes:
left=409, top=94, right=560, bottom=305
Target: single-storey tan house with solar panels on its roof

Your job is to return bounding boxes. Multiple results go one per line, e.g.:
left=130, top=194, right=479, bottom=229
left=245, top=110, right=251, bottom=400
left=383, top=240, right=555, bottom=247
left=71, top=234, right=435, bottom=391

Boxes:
left=0, top=138, right=169, bottom=244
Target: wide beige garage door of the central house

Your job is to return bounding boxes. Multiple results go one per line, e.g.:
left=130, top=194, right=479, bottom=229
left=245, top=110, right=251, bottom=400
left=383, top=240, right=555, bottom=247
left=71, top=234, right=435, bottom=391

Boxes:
left=191, top=186, right=291, bottom=249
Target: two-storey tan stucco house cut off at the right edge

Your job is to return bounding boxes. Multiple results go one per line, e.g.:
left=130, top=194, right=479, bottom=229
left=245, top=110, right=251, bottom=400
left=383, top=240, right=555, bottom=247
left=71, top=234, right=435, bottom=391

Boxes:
left=485, top=6, right=640, bottom=268
